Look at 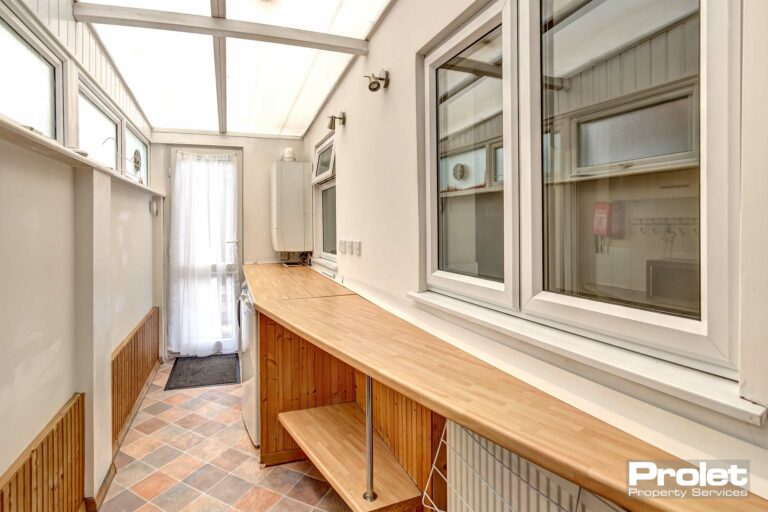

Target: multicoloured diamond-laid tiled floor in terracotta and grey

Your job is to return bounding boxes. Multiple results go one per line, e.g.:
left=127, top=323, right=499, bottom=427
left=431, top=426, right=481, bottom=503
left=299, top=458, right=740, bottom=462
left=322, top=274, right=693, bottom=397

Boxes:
left=102, top=361, right=349, bottom=512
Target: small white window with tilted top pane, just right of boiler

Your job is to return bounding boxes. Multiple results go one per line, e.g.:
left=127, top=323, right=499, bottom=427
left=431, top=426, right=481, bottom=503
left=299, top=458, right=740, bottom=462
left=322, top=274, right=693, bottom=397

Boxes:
left=312, top=132, right=338, bottom=267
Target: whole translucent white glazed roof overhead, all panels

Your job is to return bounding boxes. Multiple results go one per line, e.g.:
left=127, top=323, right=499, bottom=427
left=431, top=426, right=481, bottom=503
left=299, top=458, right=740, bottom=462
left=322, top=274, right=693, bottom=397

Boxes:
left=80, top=0, right=390, bottom=136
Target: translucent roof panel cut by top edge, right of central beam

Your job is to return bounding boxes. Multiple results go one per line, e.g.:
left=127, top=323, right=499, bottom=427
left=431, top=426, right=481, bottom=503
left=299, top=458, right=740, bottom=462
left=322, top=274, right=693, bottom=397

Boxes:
left=225, top=0, right=389, bottom=38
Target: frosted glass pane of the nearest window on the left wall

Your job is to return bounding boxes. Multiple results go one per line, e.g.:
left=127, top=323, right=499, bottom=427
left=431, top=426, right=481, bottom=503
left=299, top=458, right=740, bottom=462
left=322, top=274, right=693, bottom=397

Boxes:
left=0, top=20, right=56, bottom=138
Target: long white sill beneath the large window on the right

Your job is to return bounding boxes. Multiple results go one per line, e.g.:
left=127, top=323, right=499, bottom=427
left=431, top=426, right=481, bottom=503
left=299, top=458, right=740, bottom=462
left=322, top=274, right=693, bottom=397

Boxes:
left=408, top=292, right=768, bottom=426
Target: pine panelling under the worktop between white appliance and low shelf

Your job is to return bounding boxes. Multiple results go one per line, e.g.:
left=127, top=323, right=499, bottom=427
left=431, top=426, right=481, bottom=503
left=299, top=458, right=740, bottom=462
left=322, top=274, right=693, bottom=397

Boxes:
left=259, top=314, right=355, bottom=465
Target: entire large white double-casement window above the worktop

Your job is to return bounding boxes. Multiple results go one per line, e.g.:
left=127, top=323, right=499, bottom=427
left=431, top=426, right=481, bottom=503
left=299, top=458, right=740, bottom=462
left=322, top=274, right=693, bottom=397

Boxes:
left=425, top=0, right=741, bottom=378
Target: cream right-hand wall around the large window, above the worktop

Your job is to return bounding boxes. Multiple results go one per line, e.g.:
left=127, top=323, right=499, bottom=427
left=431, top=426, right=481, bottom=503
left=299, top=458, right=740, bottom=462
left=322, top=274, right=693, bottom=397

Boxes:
left=304, top=0, right=768, bottom=495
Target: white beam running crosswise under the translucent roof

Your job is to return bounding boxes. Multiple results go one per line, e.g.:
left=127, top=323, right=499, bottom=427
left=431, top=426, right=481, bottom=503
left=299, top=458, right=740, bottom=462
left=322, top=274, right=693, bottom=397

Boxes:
left=74, top=2, right=368, bottom=55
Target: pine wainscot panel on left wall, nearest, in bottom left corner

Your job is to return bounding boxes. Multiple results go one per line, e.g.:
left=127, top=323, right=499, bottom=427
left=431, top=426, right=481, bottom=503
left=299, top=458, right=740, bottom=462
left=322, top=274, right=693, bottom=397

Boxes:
left=0, top=393, right=85, bottom=512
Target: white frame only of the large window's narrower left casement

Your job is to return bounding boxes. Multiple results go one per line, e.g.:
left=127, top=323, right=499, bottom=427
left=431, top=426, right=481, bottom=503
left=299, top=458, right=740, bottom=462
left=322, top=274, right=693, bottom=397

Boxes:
left=424, top=0, right=519, bottom=311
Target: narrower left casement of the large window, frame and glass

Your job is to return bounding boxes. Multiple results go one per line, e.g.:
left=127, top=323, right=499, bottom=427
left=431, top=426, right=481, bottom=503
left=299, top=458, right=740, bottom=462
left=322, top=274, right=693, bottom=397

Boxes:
left=424, top=1, right=518, bottom=310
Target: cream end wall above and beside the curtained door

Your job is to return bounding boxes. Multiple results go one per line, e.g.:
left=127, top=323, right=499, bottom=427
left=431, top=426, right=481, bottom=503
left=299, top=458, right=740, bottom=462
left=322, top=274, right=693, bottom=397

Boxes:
left=152, top=132, right=305, bottom=263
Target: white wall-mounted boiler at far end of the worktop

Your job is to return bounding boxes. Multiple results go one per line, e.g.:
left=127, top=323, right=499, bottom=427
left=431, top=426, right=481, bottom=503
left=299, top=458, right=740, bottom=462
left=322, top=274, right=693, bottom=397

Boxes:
left=271, top=161, right=312, bottom=252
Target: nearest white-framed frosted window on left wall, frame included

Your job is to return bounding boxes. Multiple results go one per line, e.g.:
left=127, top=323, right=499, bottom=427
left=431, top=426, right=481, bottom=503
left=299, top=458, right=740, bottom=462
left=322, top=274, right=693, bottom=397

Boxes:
left=0, top=4, right=64, bottom=144
